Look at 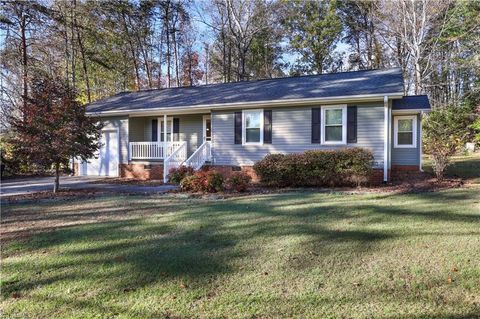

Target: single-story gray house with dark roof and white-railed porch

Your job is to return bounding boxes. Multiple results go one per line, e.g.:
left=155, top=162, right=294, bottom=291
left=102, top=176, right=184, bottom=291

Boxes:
left=78, top=68, right=430, bottom=181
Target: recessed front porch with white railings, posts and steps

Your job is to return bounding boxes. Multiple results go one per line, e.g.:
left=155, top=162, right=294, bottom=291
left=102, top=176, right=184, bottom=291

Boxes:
left=128, top=114, right=212, bottom=182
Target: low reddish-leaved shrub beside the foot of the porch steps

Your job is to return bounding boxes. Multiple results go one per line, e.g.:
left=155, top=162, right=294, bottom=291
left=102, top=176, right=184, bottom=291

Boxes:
left=180, top=169, right=223, bottom=193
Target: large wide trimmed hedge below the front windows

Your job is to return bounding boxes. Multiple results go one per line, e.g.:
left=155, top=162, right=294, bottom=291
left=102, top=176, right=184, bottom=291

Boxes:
left=253, top=148, right=373, bottom=187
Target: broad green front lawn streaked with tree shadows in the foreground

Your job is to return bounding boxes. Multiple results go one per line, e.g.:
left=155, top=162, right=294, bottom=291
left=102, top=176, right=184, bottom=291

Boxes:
left=1, top=189, right=480, bottom=318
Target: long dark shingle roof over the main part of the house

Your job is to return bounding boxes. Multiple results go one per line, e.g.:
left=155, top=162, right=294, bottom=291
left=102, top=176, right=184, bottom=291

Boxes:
left=87, top=68, right=403, bottom=112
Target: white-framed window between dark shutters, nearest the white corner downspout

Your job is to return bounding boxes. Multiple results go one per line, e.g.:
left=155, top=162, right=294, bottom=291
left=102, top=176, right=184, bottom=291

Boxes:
left=321, top=105, right=347, bottom=144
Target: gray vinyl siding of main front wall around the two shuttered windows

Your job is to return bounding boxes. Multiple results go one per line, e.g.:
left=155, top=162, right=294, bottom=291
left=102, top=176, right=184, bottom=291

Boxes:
left=212, top=104, right=384, bottom=166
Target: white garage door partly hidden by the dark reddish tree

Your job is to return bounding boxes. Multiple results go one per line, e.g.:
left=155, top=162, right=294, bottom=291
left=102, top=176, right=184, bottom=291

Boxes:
left=82, top=131, right=118, bottom=176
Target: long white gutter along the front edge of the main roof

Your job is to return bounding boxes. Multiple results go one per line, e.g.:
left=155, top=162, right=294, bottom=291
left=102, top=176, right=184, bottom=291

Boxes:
left=87, top=92, right=403, bottom=116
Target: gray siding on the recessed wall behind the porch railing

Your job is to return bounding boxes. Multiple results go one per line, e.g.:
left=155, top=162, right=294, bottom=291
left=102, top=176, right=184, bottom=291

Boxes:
left=130, top=114, right=204, bottom=156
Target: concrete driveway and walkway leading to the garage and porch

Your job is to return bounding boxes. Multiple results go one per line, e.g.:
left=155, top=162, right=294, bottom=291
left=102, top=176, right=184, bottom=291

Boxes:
left=0, top=176, right=176, bottom=197
